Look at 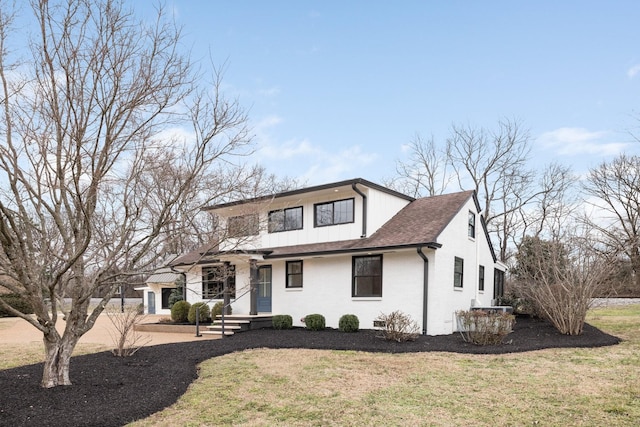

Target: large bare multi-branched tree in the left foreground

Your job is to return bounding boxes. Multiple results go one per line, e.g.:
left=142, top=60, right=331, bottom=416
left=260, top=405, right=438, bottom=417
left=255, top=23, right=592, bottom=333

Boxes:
left=0, top=0, right=255, bottom=387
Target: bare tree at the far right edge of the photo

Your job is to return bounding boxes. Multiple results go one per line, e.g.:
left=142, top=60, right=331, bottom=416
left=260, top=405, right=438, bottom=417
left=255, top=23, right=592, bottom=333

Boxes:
left=584, top=154, right=640, bottom=289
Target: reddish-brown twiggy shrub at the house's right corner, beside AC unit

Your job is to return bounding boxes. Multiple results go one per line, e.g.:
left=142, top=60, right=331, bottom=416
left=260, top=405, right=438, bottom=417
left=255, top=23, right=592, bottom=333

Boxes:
left=456, top=310, right=516, bottom=345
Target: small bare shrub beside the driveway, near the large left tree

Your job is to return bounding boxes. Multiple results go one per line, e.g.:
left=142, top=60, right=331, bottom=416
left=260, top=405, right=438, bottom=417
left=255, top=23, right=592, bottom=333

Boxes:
left=105, top=306, right=151, bottom=357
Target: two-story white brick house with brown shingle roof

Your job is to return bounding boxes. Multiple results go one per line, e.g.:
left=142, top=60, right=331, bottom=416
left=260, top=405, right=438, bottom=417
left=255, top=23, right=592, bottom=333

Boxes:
left=149, top=179, right=504, bottom=335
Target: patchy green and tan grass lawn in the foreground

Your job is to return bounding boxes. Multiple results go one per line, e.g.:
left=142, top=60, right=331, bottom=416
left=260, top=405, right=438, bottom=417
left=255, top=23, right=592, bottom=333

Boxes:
left=131, top=305, right=640, bottom=427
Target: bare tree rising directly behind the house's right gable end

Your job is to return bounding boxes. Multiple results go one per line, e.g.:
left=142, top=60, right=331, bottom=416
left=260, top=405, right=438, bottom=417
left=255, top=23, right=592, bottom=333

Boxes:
left=389, top=119, right=573, bottom=260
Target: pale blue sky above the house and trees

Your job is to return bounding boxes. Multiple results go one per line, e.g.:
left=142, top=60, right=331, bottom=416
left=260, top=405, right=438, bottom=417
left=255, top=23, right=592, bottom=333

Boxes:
left=138, top=0, right=640, bottom=184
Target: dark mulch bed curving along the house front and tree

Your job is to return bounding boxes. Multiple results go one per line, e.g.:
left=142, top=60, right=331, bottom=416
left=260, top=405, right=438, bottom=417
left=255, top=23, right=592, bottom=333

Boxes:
left=0, top=318, right=620, bottom=426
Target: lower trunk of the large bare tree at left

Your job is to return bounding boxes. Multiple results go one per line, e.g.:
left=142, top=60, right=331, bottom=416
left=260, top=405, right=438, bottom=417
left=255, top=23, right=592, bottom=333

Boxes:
left=42, top=334, right=78, bottom=388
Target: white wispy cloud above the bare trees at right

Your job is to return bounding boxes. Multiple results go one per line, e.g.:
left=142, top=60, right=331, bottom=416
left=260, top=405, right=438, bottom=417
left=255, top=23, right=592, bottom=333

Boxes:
left=538, top=128, right=629, bottom=160
